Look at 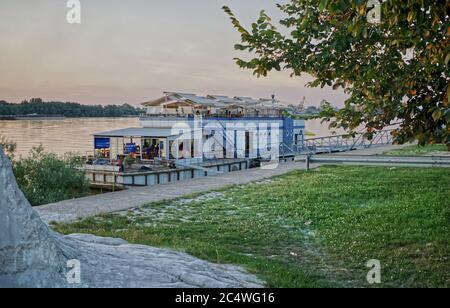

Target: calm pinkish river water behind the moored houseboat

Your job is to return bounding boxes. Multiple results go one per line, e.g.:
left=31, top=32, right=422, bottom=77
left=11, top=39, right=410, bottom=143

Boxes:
left=0, top=118, right=342, bottom=156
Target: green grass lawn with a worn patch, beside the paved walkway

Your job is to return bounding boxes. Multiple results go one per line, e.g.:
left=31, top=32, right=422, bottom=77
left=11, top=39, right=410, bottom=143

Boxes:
left=54, top=166, right=450, bottom=287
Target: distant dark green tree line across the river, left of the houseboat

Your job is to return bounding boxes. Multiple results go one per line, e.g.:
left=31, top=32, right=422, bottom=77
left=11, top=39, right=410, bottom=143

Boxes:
left=0, top=98, right=143, bottom=118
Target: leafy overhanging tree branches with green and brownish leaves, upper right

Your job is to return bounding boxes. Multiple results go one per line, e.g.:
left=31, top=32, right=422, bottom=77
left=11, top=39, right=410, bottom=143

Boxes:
left=224, top=0, right=450, bottom=147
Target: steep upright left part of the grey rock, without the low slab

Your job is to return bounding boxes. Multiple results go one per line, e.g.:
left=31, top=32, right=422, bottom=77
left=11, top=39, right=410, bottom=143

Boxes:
left=0, top=146, right=66, bottom=287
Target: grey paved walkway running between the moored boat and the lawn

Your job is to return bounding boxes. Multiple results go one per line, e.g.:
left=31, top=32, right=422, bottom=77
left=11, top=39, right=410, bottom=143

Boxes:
left=35, top=146, right=412, bottom=224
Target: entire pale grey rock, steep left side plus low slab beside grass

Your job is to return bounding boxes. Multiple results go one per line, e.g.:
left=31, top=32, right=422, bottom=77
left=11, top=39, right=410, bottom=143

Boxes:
left=0, top=147, right=261, bottom=288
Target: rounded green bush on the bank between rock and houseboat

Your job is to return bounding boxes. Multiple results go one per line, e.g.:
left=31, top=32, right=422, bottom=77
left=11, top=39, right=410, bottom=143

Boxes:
left=13, top=146, right=89, bottom=206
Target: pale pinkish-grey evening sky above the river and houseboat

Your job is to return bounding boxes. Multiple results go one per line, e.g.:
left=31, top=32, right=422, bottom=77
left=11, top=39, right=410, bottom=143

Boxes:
left=0, top=0, right=345, bottom=106
